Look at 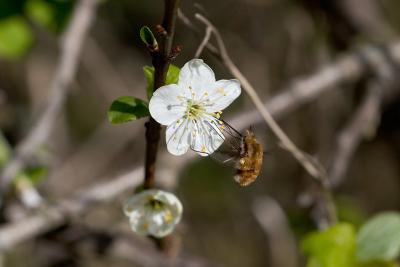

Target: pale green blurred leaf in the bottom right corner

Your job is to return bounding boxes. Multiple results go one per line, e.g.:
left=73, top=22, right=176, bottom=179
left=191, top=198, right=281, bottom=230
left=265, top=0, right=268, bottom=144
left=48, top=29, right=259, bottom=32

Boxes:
left=356, top=212, right=400, bottom=262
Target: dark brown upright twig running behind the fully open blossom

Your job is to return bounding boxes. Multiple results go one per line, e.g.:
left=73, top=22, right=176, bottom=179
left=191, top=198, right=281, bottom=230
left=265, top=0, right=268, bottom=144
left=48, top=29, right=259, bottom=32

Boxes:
left=143, top=0, right=180, bottom=191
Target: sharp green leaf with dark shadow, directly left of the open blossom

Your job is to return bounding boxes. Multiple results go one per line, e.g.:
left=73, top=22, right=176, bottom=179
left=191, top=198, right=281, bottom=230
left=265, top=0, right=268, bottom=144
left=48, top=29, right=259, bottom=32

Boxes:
left=108, top=96, right=149, bottom=124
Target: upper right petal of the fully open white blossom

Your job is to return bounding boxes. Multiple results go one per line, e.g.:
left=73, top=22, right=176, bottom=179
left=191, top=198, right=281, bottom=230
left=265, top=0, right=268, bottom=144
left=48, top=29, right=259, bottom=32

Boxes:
left=205, top=79, right=241, bottom=112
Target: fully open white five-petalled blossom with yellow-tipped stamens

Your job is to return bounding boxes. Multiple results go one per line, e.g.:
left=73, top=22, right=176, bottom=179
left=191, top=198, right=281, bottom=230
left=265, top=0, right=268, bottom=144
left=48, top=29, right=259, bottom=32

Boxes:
left=149, top=59, right=241, bottom=156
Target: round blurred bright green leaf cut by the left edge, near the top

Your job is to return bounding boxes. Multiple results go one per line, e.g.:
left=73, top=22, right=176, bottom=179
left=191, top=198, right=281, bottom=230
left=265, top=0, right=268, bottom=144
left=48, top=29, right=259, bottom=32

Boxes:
left=0, top=16, right=33, bottom=59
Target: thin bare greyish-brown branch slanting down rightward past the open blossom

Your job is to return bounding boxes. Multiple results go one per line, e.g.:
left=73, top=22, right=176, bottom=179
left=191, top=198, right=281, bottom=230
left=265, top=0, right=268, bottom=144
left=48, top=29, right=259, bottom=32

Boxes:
left=195, top=14, right=325, bottom=180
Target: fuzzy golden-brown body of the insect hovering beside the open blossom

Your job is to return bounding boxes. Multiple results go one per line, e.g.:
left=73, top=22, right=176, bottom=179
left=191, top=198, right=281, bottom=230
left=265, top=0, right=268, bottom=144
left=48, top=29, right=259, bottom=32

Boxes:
left=234, top=130, right=264, bottom=186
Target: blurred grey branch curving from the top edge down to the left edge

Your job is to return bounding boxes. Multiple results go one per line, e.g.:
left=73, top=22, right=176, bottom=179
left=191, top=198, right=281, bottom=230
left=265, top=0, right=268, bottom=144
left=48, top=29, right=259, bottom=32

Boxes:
left=1, top=0, right=98, bottom=197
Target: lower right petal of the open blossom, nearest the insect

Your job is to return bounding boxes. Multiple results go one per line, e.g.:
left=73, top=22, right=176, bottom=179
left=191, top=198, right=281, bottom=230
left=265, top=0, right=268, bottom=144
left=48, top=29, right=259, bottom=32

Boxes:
left=191, top=116, right=225, bottom=156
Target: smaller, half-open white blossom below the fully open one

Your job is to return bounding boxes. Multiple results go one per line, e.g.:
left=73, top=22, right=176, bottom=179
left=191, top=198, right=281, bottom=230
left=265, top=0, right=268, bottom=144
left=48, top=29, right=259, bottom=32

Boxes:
left=123, top=189, right=183, bottom=238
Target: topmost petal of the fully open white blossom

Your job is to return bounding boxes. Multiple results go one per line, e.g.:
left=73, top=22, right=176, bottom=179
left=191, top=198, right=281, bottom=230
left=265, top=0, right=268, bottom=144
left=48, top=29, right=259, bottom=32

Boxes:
left=178, top=59, right=215, bottom=100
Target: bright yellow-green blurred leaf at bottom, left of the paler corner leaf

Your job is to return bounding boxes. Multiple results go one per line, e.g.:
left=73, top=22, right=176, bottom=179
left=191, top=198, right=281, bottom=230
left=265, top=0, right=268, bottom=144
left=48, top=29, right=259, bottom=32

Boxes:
left=302, top=223, right=355, bottom=267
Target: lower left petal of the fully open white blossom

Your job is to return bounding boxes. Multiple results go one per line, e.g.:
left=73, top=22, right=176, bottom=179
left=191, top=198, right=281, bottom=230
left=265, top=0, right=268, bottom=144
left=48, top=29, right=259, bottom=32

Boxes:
left=165, top=119, right=192, bottom=156
